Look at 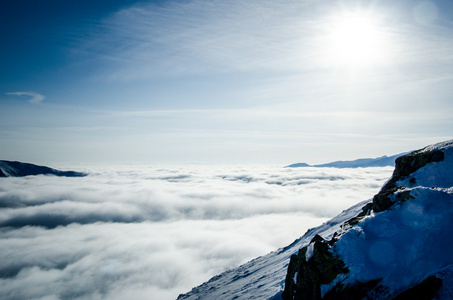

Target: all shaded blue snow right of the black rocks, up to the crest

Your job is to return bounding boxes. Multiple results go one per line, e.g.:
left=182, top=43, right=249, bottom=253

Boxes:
left=328, top=142, right=453, bottom=298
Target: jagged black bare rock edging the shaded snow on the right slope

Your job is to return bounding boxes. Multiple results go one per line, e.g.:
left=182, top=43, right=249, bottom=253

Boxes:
left=282, top=143, right=445, bottom=300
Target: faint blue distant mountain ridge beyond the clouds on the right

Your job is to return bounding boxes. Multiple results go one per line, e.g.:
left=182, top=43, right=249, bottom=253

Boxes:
left=285, top=152, right=408, bottom=168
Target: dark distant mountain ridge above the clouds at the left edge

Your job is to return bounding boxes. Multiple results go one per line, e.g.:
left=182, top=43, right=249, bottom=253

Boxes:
left=0, top=160, right=87, bottom=177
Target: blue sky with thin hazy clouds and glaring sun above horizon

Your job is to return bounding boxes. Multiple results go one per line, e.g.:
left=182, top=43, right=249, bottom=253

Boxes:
left=0, top=0, right=453, bottom=164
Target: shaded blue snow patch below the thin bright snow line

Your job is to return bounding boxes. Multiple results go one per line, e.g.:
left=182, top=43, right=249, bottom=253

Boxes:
left=335, top=188, right=453, bottom=288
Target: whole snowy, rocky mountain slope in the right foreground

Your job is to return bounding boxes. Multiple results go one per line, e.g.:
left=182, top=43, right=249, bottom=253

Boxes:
left=178, top=140, right=453, bottom=299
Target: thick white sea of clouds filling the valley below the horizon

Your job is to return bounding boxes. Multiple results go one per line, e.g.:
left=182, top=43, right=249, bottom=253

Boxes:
left=0, top=165, right=393, bottom=300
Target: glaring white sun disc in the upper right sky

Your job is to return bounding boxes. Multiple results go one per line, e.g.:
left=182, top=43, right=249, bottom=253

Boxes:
left=325, top=11, right=386, bottom=67
